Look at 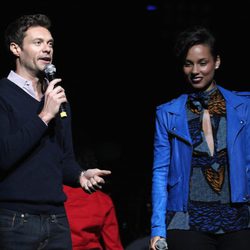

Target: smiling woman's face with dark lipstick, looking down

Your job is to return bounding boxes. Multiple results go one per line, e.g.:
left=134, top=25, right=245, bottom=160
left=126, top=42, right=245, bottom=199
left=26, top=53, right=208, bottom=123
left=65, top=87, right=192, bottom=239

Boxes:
left=183, top=44, right=220, bottom=90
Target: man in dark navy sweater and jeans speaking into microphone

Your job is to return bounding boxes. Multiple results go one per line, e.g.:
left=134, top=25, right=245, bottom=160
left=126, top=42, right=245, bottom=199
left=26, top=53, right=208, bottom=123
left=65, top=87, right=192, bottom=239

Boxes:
left=0, top=14, right=110, bottom=250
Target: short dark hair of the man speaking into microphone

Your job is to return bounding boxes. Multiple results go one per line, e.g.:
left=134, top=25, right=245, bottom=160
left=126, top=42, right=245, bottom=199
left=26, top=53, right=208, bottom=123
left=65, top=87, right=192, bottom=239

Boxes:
left=5, top=14, right=51, bottom=49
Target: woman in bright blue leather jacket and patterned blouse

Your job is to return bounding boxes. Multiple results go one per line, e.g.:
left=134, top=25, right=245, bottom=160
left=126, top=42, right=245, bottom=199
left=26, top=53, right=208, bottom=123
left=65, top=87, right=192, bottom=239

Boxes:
left=150, top=26, right=250, bottom=250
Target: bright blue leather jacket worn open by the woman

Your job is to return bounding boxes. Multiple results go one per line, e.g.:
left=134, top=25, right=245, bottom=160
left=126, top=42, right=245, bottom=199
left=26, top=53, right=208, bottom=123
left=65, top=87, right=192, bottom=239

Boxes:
left=151, top=86, right=250, bottom=237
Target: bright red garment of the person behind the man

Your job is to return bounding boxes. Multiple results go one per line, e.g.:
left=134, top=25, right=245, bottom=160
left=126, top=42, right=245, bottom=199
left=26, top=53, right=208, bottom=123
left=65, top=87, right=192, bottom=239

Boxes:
left=64, top=186, right=124, bottom=250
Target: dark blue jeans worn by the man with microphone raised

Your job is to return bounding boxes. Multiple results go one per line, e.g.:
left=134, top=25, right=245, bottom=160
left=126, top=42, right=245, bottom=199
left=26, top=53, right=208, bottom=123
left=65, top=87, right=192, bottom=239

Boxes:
left=0, top=209, right=72, bottom=250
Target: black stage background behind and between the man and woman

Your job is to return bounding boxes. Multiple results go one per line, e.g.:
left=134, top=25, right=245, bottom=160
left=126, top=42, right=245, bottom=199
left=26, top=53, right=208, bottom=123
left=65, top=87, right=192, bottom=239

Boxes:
left=0, top=0, right=250, bottom=246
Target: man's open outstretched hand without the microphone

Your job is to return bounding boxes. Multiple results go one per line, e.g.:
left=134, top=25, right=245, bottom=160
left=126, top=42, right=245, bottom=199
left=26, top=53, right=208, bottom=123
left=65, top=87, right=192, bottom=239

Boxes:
left=80, top=168, right=111, bottom=194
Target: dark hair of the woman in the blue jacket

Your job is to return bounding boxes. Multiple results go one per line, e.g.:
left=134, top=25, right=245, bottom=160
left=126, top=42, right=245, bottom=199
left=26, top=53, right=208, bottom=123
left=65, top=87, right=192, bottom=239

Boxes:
left=174, top=25, right=218, bottom=64
